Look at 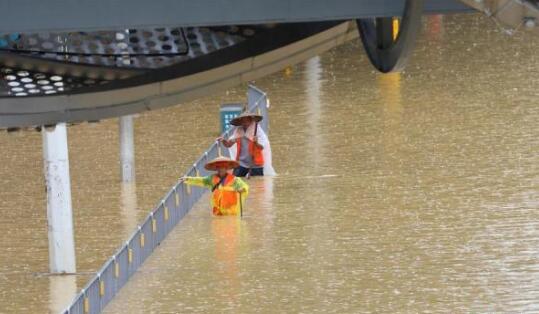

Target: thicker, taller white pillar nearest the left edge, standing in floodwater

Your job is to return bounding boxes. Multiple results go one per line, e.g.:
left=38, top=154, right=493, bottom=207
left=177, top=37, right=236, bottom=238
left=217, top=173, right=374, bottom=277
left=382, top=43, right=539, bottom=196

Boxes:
left=41, top=123, right=76, bottom=273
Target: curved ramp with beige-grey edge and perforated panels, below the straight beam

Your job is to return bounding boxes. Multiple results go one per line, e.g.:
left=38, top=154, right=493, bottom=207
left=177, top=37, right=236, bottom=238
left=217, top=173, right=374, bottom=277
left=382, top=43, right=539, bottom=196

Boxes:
left=0, top=22, right=357, bottom=128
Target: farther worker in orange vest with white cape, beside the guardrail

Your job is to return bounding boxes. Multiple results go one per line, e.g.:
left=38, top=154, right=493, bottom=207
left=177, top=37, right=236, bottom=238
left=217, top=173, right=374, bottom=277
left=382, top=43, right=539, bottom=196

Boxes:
left=217, top=112, right=269, bottom=177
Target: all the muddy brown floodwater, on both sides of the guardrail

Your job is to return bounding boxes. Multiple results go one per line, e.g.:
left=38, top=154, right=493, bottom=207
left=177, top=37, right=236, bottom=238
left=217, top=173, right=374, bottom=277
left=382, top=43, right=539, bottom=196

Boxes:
left=0, top=15, right=539, bottom=313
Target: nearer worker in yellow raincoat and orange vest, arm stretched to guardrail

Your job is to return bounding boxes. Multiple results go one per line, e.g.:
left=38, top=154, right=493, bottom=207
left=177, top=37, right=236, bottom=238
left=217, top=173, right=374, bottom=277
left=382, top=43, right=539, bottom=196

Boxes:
left=180, top=157, right=249, bottom=216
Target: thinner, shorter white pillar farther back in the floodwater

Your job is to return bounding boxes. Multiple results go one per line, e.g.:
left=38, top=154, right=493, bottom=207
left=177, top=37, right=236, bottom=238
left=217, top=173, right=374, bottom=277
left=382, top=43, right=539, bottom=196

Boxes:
left=120, top=116, right=135, bottom=182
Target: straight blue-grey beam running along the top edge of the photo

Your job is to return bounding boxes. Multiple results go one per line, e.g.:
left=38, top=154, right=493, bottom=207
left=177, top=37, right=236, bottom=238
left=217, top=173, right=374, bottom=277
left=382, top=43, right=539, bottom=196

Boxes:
left=0, top=0, right=470, bottom=33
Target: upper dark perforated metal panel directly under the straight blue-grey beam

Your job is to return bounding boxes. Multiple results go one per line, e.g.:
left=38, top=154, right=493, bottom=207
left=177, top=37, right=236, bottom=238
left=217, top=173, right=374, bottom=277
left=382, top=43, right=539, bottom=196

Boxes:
left=0, top=26, right=257, bottom=69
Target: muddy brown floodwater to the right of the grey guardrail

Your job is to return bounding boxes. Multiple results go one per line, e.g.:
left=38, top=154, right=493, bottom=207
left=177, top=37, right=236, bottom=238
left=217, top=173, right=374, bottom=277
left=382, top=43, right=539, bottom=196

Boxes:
left=107, top=17, right=539, bottom=313
